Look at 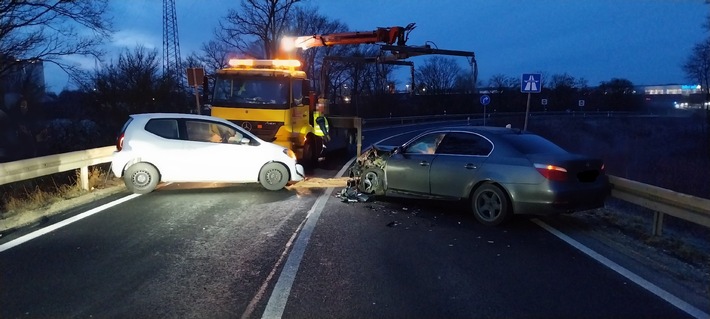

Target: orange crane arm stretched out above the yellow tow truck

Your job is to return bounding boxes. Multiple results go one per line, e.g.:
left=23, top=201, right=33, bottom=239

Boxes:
left=281, top=23, right=415, bottom=50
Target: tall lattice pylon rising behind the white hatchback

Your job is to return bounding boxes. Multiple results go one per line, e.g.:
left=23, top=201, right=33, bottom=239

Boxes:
left=163, top=0, right=183, bottom=91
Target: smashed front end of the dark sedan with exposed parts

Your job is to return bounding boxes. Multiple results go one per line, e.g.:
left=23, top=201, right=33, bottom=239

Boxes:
left=348, top=145, right=396, bottom=195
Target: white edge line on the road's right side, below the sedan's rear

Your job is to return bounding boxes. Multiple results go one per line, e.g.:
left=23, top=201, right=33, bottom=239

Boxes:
left=532, top=218, right=710, bottom=319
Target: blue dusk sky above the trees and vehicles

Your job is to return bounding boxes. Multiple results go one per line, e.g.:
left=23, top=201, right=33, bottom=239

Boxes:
left=45, top=0, right=710, bottom=91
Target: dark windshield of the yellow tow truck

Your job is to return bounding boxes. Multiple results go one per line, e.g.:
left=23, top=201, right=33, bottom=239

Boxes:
left=212, top=74, right=288, bottom=109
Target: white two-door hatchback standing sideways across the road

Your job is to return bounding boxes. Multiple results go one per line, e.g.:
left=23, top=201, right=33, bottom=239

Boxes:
left=111, top=113, right=304, bottom=194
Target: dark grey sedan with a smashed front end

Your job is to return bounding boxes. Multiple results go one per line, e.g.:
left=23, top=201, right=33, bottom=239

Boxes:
left=350, top=126, right=610, bottom=226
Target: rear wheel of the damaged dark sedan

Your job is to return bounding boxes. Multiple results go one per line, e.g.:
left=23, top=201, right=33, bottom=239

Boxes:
left=471, top=184, right=511, bottom=226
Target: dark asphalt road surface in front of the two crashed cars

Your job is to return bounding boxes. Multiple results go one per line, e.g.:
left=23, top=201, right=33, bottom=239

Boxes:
left=0, top=121, right=704, bottom=318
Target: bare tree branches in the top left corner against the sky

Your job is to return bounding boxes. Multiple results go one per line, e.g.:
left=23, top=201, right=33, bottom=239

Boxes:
left=0, top=0, right=111, bottom=76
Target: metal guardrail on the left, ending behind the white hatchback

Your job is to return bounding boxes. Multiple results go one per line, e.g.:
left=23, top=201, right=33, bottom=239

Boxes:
left=0, top=146, right=116, bottom=190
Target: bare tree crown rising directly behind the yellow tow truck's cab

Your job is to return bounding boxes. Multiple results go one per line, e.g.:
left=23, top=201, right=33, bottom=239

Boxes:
left=216, top=0, right=299, bottom=59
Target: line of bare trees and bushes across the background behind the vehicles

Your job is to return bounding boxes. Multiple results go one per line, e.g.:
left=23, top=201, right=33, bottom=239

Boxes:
left=0, top=0, right=710, bottom=160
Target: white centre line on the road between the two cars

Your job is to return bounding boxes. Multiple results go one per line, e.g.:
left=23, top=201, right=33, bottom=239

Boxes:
left=261, top=158, right=355, bottom=318
